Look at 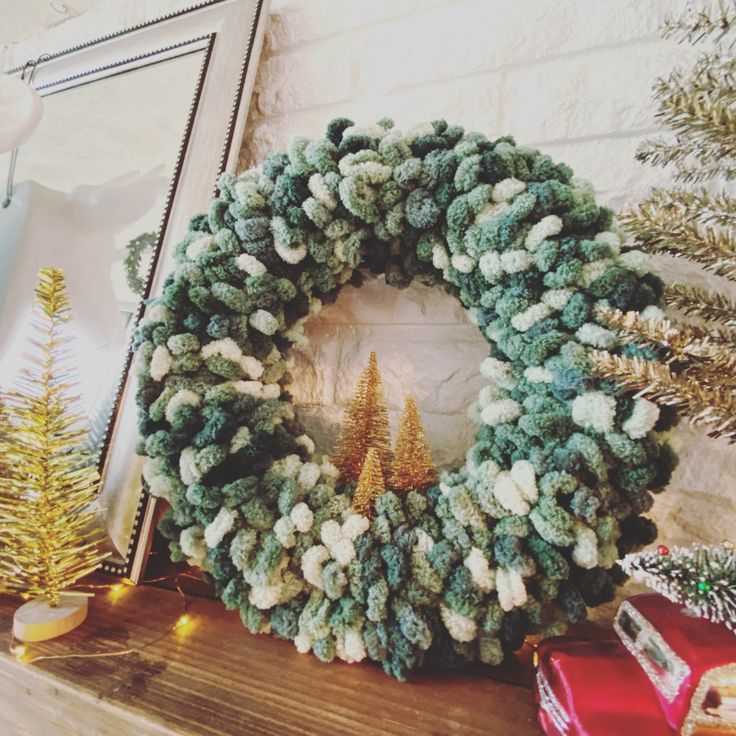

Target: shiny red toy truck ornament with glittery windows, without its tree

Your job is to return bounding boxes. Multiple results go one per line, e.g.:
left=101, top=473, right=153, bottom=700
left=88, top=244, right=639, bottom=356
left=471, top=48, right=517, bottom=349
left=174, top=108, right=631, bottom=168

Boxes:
left=536, top=593, right=736, bottom=736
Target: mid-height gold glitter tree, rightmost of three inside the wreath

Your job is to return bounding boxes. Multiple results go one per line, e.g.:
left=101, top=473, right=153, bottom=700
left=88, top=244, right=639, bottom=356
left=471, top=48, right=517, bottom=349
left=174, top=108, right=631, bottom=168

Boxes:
left=389, top=396, right=437, bottom=491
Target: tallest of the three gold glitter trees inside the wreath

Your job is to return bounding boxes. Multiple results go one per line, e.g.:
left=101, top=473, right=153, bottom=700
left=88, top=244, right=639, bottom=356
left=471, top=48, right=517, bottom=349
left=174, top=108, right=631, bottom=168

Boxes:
left=333, top=353, right=392, bottom=483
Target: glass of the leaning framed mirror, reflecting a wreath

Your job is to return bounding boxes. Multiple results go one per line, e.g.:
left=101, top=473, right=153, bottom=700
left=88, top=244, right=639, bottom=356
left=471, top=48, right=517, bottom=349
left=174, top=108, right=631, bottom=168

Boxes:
left=0, top=42, right=206, bottom=558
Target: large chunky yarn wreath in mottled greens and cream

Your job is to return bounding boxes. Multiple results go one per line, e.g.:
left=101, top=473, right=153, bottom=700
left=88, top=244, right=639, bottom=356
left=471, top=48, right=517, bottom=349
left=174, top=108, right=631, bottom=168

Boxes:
left=135, top=119, right=674, bottom=678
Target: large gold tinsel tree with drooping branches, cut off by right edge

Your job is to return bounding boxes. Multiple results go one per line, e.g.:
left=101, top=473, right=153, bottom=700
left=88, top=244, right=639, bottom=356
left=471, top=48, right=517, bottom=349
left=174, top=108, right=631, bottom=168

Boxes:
left=594, top=1, right=736, bottom=442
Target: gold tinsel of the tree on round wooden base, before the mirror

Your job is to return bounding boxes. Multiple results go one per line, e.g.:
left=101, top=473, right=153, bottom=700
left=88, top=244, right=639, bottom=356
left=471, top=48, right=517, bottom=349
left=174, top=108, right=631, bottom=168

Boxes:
left=0, top=268, right=107, bottom=606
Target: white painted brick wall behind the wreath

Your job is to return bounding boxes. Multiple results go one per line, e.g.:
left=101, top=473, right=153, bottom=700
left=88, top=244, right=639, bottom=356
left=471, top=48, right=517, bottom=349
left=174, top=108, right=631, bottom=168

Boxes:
left=241, top=0, right=736, bottom=542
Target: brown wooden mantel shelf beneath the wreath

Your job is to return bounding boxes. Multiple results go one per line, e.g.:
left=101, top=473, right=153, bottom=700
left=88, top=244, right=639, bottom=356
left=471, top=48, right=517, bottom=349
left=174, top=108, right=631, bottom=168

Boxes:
left=0, top=586, right=540, bottom=736
